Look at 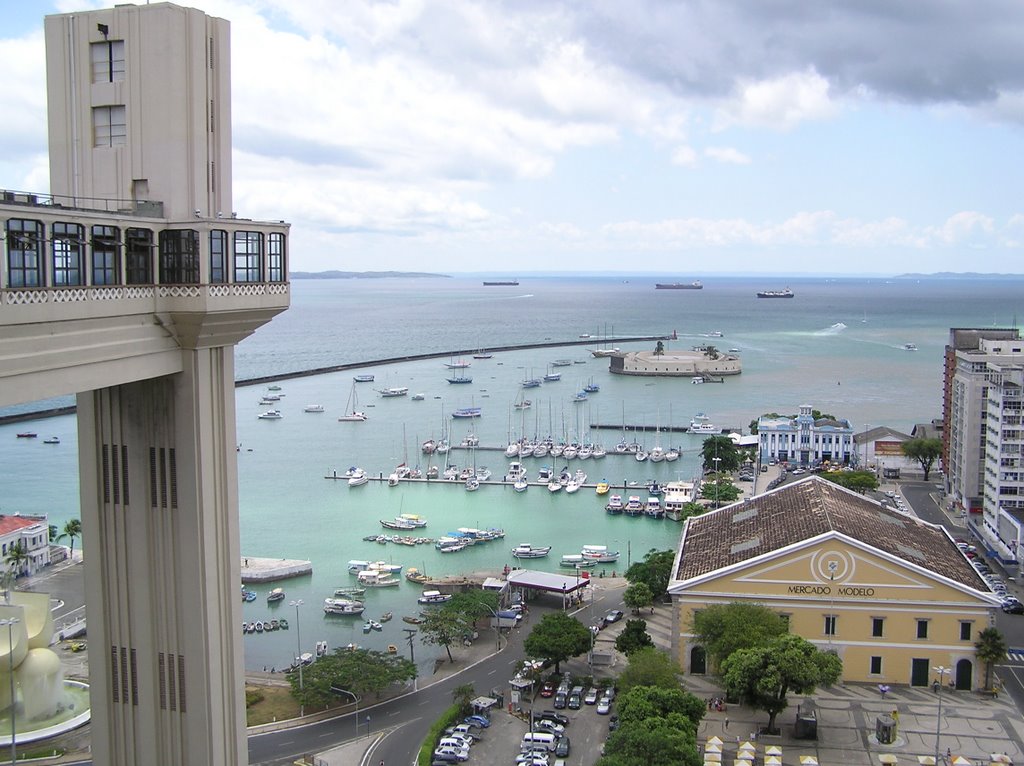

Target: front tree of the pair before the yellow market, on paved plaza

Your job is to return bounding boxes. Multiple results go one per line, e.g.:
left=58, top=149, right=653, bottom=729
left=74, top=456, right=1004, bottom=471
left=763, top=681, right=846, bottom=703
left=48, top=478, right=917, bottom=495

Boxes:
left=722, top=633, right=843, bottom=734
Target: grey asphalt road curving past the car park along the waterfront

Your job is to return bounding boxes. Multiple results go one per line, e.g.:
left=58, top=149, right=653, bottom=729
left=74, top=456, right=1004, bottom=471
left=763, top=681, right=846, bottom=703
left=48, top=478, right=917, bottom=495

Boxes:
left=249, top=588, right=622, bottom=766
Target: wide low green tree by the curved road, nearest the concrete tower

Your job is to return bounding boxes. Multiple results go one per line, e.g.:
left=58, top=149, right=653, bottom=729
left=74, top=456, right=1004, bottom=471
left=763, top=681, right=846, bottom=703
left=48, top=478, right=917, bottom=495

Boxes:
left=288, top=648, right=416, bottom=708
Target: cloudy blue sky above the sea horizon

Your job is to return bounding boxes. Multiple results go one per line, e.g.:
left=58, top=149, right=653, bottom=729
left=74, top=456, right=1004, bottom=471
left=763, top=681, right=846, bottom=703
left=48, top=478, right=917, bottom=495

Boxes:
left=0, top=0, right=1024, bottom=278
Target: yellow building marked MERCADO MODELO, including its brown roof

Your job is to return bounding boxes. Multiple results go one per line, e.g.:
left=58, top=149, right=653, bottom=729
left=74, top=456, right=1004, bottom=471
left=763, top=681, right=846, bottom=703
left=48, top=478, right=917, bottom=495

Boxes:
left=669, top=476, right=999, bottom=689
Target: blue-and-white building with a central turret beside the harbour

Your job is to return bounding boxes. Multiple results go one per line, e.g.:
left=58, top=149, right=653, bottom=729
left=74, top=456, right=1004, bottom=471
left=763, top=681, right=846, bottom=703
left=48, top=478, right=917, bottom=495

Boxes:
left=758, top=405, right=855, bottom=466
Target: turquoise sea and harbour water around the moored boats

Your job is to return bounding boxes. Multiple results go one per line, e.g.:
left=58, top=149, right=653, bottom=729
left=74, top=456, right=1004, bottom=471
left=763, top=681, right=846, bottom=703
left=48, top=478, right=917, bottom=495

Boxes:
left=0, top=278, right=1022, bottom=669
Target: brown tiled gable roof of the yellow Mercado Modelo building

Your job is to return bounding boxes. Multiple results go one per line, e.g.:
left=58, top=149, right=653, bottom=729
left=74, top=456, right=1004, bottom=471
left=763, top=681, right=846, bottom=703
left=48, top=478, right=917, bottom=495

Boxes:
left=676, top=476, right=988, bottom=592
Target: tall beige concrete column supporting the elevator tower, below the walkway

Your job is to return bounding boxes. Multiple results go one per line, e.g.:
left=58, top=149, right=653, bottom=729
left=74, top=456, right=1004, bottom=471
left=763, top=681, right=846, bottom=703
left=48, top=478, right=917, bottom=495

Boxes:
left=78, top=346, right=248, bottom=766
